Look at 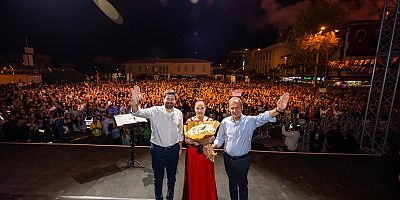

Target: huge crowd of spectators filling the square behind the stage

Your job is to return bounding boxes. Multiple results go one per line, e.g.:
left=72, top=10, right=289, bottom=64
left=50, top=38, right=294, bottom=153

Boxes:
left=0, top=79, right=378, bottom=152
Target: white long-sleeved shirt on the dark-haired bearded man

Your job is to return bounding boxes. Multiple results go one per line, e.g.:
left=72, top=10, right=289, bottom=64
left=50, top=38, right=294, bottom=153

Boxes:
left=132, top=106, right=183, bottom=147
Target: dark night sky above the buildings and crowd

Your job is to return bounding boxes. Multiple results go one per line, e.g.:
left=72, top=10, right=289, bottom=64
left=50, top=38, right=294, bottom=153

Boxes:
left=0, top=0, right=383, bottom=65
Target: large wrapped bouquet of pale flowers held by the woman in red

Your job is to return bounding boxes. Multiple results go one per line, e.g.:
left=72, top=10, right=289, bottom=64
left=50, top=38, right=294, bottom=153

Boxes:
left=185, top=121, right=219, bottom=162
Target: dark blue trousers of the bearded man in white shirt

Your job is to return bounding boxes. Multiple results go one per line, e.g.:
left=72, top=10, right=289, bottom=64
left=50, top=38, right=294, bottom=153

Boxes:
left=150, top=143, right=180, bottom=199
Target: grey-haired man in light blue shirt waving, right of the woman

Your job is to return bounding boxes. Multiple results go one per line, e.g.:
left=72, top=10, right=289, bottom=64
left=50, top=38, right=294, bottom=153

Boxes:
left=214, top=93, right=289, bottom=200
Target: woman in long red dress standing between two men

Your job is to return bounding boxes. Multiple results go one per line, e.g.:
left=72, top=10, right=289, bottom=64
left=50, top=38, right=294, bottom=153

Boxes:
left=182, top=101, right=217, bottom=200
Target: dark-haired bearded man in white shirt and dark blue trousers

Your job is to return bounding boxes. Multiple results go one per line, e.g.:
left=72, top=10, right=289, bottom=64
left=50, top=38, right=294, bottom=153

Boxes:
left=132, top=86, right=183, bottom=199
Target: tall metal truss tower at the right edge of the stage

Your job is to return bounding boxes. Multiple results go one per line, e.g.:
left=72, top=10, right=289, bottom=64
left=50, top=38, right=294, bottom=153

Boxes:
left=360, top=0, right=400, bottom=153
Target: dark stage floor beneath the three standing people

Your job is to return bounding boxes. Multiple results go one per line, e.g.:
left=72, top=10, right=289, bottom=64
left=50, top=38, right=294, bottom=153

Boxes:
left=0, top=144, right=400, bottom=200
